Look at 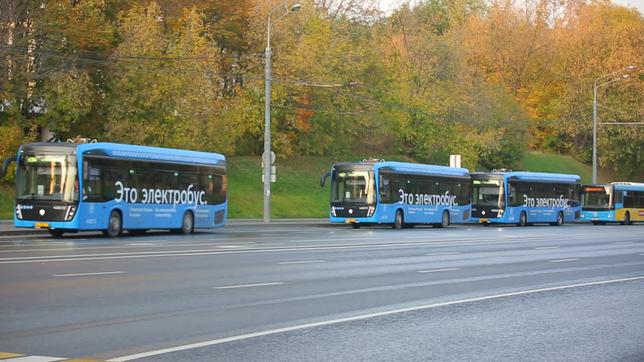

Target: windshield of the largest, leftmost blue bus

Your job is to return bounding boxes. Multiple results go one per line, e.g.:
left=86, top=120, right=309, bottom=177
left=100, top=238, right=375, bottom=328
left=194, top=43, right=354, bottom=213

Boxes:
left=16, top=155, right=78, bottom=202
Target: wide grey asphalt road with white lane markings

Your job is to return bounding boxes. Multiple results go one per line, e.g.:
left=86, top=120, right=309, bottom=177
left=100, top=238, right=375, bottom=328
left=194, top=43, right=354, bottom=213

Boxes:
left=0, top=224, right=644, bottom=361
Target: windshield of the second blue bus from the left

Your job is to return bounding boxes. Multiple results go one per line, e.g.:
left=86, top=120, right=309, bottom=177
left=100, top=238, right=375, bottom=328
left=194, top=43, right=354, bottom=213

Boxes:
left=331, top=171, right=375, bottom=204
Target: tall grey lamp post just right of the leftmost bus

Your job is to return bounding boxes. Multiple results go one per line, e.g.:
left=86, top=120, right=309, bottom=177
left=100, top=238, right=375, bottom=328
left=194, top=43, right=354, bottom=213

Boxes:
left=262, top=0, right=301, bottom=223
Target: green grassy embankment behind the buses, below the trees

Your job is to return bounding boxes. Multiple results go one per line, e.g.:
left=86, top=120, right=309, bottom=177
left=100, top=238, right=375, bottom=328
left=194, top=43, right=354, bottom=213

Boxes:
left=0, top=153, right=610, bottom=219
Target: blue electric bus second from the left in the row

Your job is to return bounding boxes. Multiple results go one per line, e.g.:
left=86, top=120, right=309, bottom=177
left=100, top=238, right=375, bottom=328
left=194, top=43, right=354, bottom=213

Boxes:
left=320, top=161, right=470, bottom=229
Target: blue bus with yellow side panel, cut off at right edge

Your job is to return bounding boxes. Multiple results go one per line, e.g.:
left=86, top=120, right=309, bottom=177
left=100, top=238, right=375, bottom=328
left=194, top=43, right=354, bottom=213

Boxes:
left=581, top=182, right=644, bottom=225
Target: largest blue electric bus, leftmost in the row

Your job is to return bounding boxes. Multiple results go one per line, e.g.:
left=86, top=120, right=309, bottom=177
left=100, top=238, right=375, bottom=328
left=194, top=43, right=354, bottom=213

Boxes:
left=8, top=142, right=227, bottom=237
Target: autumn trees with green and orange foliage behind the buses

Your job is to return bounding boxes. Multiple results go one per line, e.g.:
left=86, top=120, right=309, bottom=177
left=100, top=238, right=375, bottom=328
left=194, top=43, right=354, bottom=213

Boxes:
left=0, top=0, right=644, bottom=180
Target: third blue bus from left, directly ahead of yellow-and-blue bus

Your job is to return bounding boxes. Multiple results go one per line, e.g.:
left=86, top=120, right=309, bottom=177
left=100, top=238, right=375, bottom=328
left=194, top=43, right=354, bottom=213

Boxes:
left=471, top=171, right=581, bottom=226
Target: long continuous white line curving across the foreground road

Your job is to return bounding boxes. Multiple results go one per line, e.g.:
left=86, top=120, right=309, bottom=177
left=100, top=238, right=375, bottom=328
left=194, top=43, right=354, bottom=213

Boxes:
left=108, top=276, right=644, bottom=362
